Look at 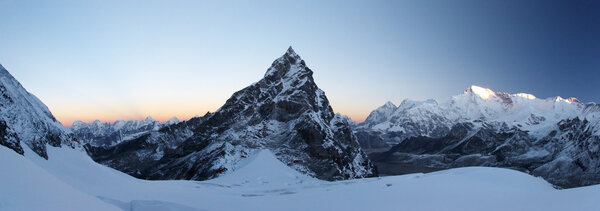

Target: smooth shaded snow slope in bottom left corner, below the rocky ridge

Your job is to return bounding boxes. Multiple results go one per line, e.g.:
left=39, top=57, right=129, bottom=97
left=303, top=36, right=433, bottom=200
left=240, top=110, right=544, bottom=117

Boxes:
left=0, top=147, right=119, bottom=210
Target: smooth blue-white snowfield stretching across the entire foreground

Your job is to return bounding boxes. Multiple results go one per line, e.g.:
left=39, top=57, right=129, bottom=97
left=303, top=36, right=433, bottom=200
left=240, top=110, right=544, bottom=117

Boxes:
left=0, top=147, right=600, bottom=210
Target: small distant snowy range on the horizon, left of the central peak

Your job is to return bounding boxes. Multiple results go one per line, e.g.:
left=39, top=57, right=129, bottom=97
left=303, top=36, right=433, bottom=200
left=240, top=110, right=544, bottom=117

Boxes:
left=70, top=116, right=179, bottom=147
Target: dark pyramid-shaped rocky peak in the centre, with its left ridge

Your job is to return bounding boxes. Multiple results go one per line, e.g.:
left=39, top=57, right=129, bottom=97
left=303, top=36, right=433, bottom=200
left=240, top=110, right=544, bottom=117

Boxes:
left=88, top=48, right=377, bottom=180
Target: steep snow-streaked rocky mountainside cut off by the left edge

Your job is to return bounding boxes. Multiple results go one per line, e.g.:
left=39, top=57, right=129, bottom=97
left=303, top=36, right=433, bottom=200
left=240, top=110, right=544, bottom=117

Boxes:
left=0, top=65, right=79, bottom=159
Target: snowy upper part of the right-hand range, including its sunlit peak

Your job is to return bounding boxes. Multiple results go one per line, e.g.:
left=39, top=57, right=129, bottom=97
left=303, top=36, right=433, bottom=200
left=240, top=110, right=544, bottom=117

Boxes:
left=360, top=86, right=587, bottom=134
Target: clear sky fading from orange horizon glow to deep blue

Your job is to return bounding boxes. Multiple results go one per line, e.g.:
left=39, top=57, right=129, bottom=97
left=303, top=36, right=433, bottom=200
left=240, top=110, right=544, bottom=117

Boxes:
left=0, top=0, right=600, bottom=125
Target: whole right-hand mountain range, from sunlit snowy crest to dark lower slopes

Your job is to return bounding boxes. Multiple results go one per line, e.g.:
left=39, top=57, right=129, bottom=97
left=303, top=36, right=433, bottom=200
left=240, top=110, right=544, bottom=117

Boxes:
left=356, top=87, right=600, bottom=187
